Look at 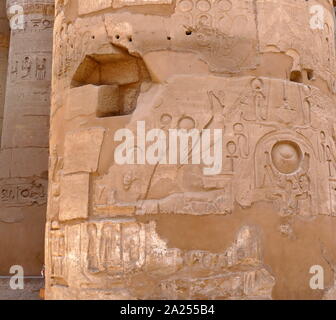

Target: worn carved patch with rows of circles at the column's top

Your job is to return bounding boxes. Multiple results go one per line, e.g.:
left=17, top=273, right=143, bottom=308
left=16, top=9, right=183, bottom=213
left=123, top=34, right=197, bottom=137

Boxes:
left=173, top=0, right=256, bottom=71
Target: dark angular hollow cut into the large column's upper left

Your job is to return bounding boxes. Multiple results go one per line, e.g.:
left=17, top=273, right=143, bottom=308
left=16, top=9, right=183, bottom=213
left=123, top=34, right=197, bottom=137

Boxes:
left=71, top=54, right=151, bottom=117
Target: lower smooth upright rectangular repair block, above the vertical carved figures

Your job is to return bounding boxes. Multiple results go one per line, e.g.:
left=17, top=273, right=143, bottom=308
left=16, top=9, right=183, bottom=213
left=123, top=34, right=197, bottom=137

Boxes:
left=59, top=173, right=90, bottom=221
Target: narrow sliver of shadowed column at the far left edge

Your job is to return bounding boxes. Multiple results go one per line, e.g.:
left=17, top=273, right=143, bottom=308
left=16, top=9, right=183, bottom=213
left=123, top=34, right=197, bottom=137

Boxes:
left=0, top=1, right=9, bottom=141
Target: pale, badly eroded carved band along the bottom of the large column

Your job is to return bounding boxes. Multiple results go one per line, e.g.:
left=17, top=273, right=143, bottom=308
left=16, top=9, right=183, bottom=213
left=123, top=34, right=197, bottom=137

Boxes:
left=79, top=222, right=275, bottom=299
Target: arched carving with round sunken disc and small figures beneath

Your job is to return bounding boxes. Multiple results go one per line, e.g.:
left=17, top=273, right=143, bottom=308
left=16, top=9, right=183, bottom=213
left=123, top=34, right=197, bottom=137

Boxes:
left=255, top=132, right=319, bottom=216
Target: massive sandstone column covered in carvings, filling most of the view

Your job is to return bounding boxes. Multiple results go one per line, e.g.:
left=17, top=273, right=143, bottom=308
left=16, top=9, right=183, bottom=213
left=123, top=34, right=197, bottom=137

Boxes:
left=46, top=0, right=336, bottom=299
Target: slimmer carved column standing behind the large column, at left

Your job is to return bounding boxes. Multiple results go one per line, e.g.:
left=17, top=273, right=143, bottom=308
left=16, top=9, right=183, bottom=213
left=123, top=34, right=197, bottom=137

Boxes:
left=0, top=0, right=54, bottom=275
